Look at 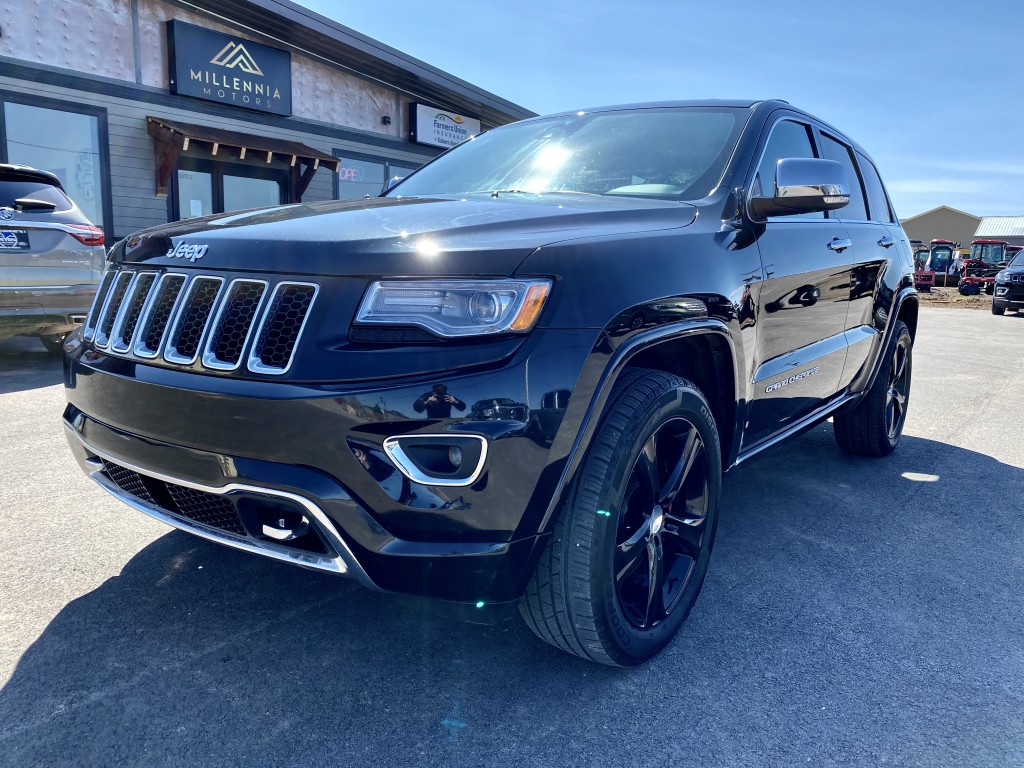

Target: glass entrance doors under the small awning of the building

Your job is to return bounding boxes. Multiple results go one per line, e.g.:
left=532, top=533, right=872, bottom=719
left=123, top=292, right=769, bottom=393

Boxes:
left=171, top=158, right=290, bottom=220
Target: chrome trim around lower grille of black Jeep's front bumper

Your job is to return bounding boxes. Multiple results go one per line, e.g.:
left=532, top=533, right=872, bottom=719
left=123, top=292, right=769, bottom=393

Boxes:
left=65, top=434, right=380, bottom=590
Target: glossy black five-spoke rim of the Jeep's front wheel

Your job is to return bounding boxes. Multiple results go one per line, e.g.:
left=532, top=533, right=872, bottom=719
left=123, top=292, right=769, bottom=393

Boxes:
left=614, top=418, right=711, bottom=629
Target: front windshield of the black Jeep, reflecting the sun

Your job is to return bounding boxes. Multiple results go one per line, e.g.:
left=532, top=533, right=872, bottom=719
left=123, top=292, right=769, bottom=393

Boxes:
left=389, top=108, right=746, bottom=200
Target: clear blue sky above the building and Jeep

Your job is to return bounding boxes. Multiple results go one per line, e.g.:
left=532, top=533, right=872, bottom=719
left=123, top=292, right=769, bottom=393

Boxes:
left=301, top=0, right=1024, bottom=218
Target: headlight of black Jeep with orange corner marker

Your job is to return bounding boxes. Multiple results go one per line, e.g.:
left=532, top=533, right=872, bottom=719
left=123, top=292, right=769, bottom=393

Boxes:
left=355, top=280, right=551, bottom=337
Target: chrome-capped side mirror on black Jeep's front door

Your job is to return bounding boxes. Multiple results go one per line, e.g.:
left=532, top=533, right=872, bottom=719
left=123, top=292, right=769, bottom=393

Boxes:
left=751, top=158, right=850, bottom=217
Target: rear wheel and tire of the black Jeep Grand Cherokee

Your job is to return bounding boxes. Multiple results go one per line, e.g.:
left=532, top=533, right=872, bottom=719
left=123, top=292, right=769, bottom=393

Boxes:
left=833, top=321, right=913, bottom=456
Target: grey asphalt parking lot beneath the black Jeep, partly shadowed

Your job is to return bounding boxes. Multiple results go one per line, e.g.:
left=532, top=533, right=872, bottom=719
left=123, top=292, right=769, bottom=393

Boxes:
left=0, top=308, right=1024, bottom=768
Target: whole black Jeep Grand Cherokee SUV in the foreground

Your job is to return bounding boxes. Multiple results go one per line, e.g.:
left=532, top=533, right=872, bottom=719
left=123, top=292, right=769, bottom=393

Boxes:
left=63, top=101, right=918, bottom=665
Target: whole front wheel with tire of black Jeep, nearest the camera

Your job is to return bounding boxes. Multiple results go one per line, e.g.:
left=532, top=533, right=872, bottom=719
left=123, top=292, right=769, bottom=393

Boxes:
left=519, top=369, right=722, bottom=667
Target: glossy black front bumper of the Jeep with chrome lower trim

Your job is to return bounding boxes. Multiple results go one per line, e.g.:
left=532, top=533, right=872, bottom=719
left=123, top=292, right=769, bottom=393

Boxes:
left=65, top=332, right=595, bottom=621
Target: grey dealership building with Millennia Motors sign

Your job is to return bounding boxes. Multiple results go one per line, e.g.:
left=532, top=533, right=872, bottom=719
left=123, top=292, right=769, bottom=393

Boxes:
left=0, top=0, right=534, bottom=242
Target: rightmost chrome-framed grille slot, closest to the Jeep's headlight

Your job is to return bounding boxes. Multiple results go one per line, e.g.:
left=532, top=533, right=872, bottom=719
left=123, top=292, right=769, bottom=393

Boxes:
left=248, top=281, right=319, bottom=376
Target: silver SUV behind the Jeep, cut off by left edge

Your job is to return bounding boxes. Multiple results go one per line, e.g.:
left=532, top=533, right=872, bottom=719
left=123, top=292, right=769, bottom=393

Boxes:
left=0, top=164, right=104, bottom=353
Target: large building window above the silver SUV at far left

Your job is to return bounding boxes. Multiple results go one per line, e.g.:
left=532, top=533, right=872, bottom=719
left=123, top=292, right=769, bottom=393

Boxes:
left=0, top=95, right=113, bottom=237
